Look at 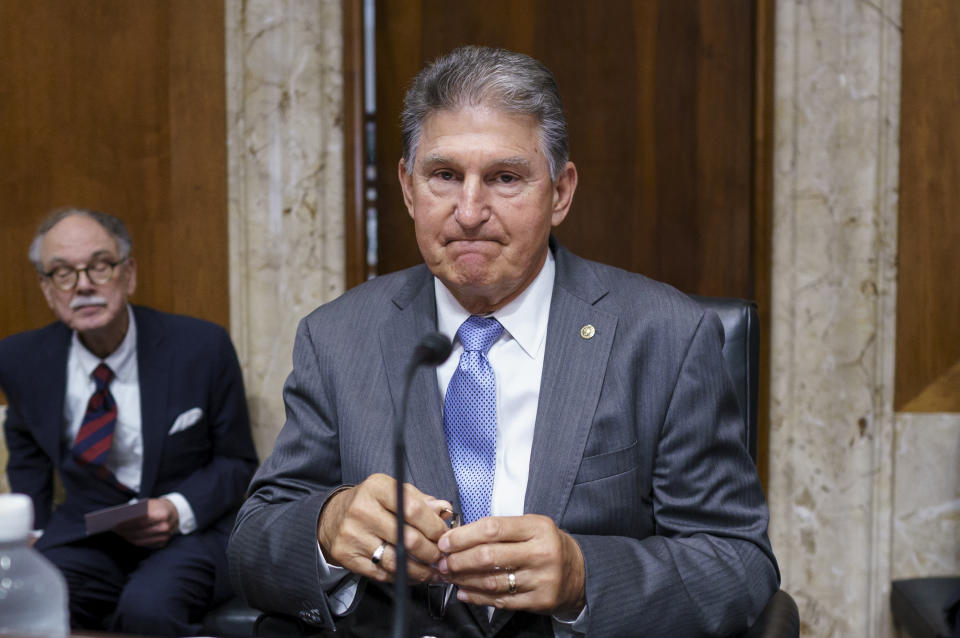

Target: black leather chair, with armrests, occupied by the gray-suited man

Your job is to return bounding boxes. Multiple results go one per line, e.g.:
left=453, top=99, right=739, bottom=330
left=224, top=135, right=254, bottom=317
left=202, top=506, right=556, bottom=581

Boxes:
left=203, top=295, right=800, bottom=638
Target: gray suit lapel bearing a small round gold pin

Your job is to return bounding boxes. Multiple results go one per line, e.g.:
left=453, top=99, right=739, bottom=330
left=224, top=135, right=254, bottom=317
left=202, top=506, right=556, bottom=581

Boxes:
left=524, top=244, right=617, bottom=524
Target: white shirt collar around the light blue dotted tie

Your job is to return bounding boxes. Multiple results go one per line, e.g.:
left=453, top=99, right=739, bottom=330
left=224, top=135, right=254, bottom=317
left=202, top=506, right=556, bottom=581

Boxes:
left=433, top=250, right=556, bottom=357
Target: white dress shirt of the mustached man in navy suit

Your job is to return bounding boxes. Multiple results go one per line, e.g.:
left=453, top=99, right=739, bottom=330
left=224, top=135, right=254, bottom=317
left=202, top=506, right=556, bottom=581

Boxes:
left=63, top=305, right=197, bottom=534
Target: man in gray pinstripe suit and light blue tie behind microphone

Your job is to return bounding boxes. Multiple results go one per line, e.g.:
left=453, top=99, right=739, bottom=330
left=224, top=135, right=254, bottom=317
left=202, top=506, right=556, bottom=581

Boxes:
left=229, top=47, right=779, bottom=636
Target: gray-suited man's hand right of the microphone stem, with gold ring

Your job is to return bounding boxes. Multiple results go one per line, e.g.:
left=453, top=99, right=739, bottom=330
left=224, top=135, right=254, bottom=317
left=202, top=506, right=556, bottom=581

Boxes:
left=438, top=514, right=586, bottom=619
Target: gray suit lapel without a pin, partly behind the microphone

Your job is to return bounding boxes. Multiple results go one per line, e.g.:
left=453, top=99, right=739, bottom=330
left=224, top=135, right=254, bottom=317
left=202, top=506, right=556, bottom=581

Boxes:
left=380, top=267, right=458, bottom=505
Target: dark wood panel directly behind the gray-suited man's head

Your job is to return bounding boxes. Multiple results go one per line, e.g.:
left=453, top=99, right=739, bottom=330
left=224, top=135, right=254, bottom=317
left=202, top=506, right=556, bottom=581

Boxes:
left=377, top=0, right=758, bottom=298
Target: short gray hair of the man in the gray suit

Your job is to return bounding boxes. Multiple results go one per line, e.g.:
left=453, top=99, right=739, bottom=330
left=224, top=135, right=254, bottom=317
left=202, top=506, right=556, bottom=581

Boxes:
left=400, top=46, right=570, bottom=179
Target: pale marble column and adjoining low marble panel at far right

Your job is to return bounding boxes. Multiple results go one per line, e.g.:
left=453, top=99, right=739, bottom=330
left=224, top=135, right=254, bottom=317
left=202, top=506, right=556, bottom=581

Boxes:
left=768, top=0, right=960, bottom=637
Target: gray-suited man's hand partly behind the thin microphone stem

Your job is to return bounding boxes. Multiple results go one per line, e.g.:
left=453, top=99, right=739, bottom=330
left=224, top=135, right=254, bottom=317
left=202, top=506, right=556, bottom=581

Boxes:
left=317, top=474, right=452, bottom=583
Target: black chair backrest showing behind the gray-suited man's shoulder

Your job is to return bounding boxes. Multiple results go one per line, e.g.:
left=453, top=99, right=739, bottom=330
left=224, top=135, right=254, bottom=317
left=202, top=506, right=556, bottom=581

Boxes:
left=690, top=295, right=760, bottom=463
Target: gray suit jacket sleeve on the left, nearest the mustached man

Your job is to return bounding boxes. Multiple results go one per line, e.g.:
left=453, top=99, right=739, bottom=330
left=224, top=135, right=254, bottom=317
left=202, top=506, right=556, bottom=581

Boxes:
left=228, top=319, right=341, bottom=627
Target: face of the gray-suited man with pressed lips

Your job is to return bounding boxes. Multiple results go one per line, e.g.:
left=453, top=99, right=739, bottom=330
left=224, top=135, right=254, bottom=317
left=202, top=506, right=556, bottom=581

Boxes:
left=400, top=107, right=577, bottom=313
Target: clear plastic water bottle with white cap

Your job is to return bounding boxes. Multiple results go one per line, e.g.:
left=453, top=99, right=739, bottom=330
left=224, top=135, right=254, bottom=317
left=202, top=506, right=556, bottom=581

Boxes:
left=0, top=494, right=70, bottom=636
